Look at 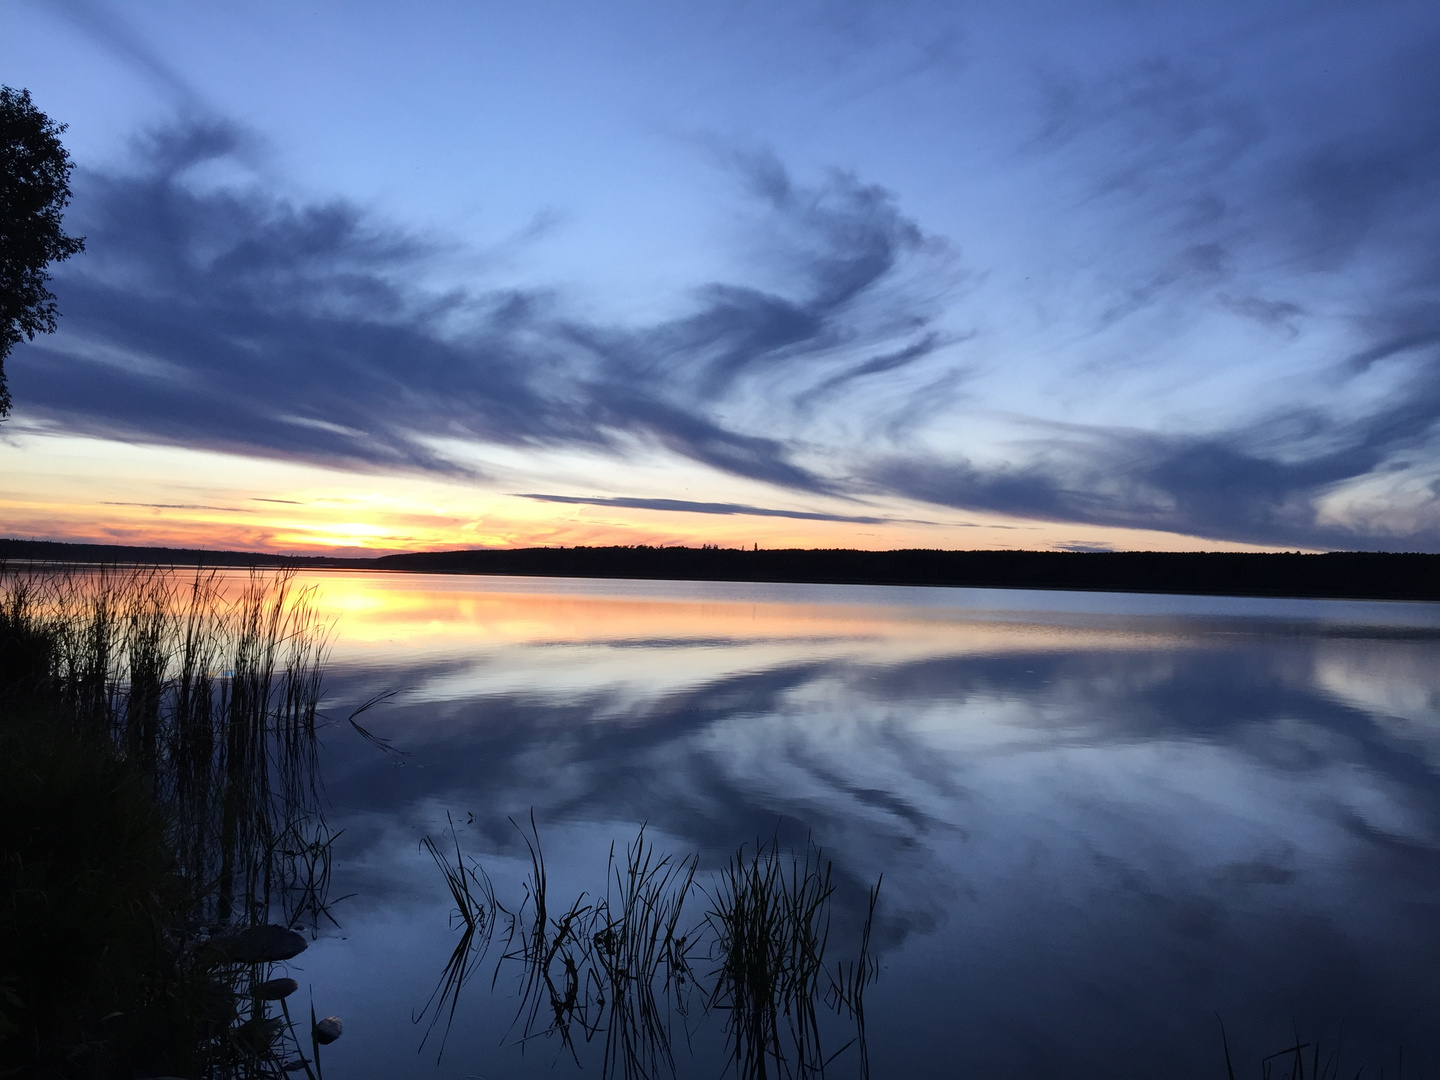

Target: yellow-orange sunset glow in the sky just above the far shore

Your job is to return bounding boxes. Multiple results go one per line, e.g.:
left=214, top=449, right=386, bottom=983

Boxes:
left=0, top=435, right=1301, bottom=557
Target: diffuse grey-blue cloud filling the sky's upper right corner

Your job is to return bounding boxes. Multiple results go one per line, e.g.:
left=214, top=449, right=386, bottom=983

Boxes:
left=1025, top=21, right=1440, bottom=324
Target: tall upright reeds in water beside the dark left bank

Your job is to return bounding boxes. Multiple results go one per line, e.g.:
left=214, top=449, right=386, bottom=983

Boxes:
left=0, top=567, right=328, bottom=923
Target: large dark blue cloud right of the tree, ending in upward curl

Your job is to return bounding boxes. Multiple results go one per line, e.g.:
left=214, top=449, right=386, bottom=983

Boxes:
left=16, top=122, right=944, bottom=491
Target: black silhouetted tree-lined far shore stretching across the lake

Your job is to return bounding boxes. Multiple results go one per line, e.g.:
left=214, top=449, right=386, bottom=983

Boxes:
left=0, top=539, right=1440, bottom=600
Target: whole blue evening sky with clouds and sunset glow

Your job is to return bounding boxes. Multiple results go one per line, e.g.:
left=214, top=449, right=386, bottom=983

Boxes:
left=0, top=0, right=1440, bottom=553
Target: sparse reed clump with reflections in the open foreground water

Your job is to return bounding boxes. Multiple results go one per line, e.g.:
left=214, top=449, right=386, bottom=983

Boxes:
left=413, top=815, right=880, bottom=1080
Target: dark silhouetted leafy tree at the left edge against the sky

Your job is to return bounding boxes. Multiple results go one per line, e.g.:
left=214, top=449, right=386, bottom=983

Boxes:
left=0, top=86, right=85, bottom=418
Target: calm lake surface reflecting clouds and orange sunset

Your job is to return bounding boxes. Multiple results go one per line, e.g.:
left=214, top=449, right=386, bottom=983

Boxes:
left=283, top=575, right=1440, bottom=1080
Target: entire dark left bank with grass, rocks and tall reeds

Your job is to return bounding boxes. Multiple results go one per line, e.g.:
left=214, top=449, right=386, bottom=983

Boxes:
left=0, top=567, right=341, bottom=1077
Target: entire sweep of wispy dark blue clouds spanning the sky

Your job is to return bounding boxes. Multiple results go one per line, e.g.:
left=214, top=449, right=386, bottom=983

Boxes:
left=13, top=9, right=1440, bottom=547
